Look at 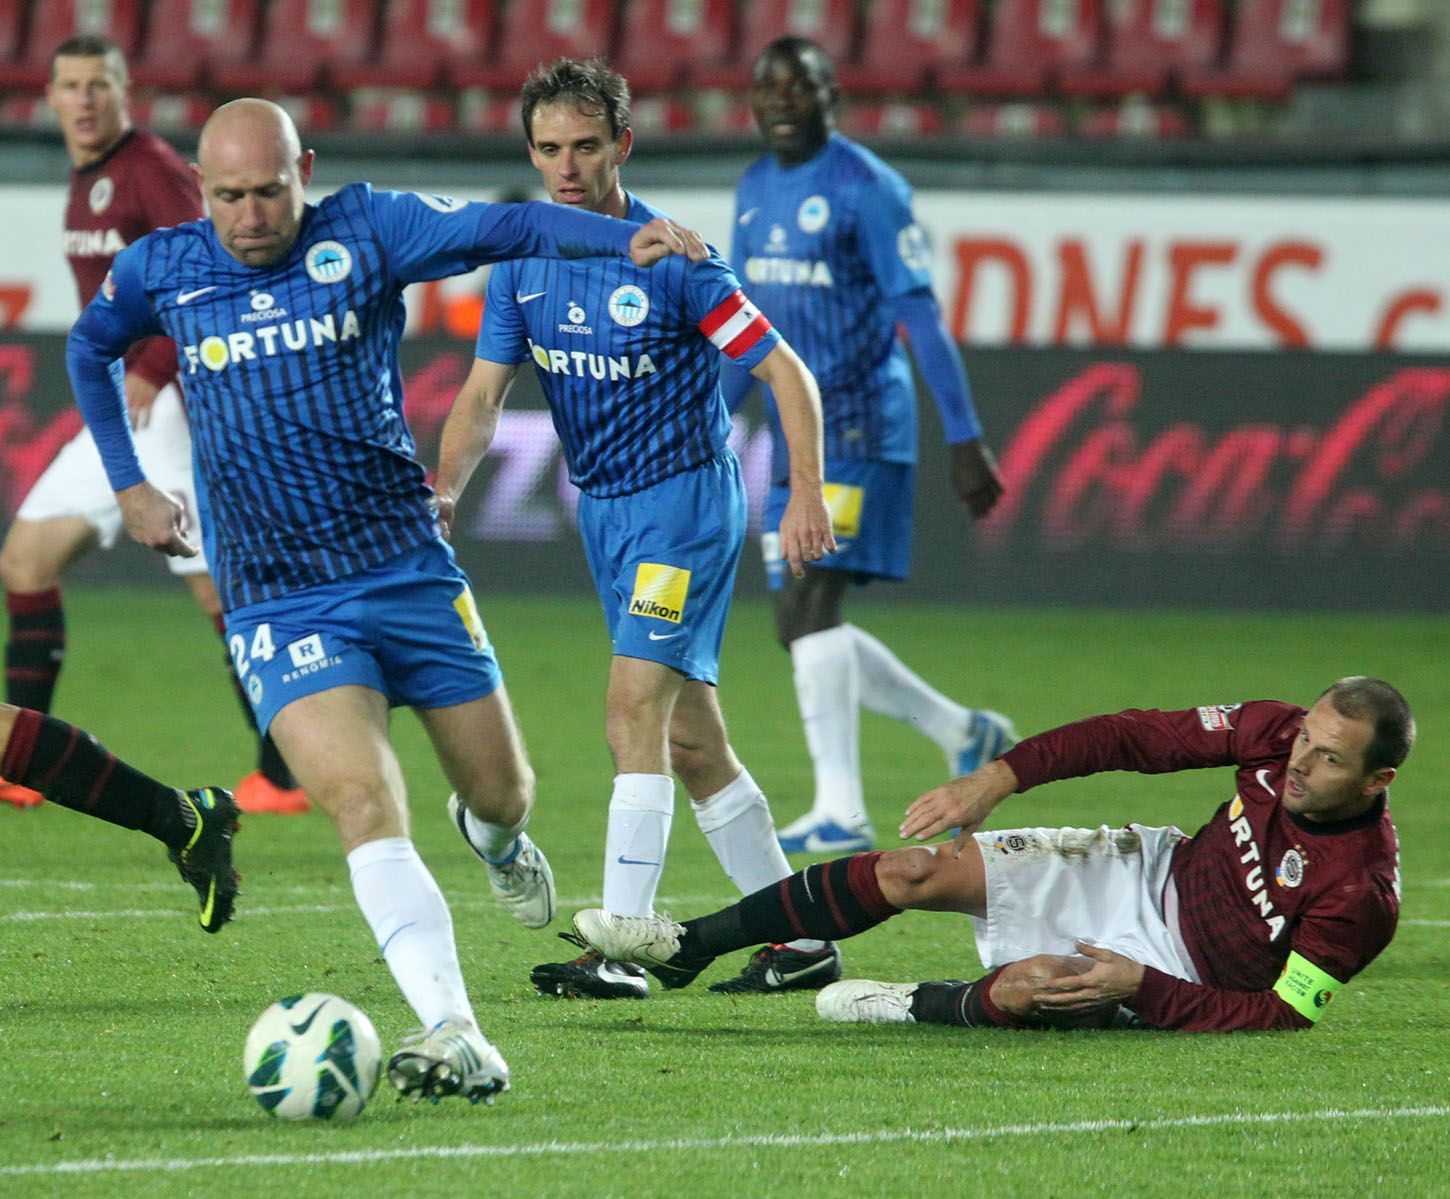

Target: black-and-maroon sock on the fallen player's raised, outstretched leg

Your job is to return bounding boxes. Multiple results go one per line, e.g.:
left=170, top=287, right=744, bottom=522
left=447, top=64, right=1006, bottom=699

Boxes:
left=680, top=851, right=900, bottom=958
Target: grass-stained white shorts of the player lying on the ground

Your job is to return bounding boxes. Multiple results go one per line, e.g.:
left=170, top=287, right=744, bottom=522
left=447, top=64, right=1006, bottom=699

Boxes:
left=972, top=825, right=1199, bottom=983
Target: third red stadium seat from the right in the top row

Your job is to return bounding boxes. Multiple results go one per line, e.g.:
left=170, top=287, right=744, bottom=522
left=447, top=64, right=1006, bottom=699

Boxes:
left=937, top=0, right=1103, bottom=96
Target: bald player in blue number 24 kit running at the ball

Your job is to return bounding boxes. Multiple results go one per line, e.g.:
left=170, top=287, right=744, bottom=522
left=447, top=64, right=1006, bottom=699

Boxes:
left=67, top=100, right=705, bottom=1102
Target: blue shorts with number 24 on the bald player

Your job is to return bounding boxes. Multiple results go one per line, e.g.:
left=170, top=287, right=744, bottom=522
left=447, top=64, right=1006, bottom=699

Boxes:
left=226, top=539, right=503, bottom=732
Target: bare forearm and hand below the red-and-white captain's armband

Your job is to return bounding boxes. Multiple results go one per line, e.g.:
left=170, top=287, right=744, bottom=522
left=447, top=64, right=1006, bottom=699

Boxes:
left=751, top=342, right=835, bottom=578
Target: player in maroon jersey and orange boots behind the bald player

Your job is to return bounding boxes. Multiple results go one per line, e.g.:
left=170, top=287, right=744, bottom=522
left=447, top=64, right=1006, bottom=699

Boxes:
left=0, top=33, right=307, bottom=812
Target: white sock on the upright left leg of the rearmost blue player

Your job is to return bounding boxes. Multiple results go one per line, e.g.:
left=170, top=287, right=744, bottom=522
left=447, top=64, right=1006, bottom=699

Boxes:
left=790, top=625, right=866, bottom=828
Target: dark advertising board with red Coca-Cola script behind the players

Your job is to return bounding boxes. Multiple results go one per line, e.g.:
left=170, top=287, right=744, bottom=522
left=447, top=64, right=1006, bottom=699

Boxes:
left=0, top=333, right=1450, bottom=610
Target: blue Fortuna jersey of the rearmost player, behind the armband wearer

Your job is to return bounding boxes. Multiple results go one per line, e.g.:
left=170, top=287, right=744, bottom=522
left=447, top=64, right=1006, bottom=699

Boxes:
left=731, top=133, right=931, bottom=476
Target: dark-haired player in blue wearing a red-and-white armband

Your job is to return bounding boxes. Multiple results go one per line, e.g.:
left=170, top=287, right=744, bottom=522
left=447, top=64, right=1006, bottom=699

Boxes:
left=436, top=58, right=841, bottom=999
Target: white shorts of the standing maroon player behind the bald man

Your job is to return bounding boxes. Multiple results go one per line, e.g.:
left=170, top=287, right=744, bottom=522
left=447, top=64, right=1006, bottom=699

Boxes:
left=16, top=383, right=206, bottom=574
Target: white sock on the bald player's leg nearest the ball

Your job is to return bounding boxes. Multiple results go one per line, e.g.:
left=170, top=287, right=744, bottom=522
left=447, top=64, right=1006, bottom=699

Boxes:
left=348, top=837, right=477, bottom=1028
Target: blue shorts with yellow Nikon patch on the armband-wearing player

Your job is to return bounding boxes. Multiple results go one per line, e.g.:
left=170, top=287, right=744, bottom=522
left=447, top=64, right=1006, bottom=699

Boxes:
left=579, top=449, right=745, bottom=684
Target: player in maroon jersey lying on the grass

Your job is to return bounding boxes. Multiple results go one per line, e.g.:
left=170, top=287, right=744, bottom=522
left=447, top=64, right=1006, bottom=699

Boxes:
left=574, top=676, right=1415, bottom=1032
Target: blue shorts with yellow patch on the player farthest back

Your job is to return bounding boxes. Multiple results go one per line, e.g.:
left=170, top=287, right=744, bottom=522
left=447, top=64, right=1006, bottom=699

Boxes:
left=760, top=458, right=916, bottom=592
